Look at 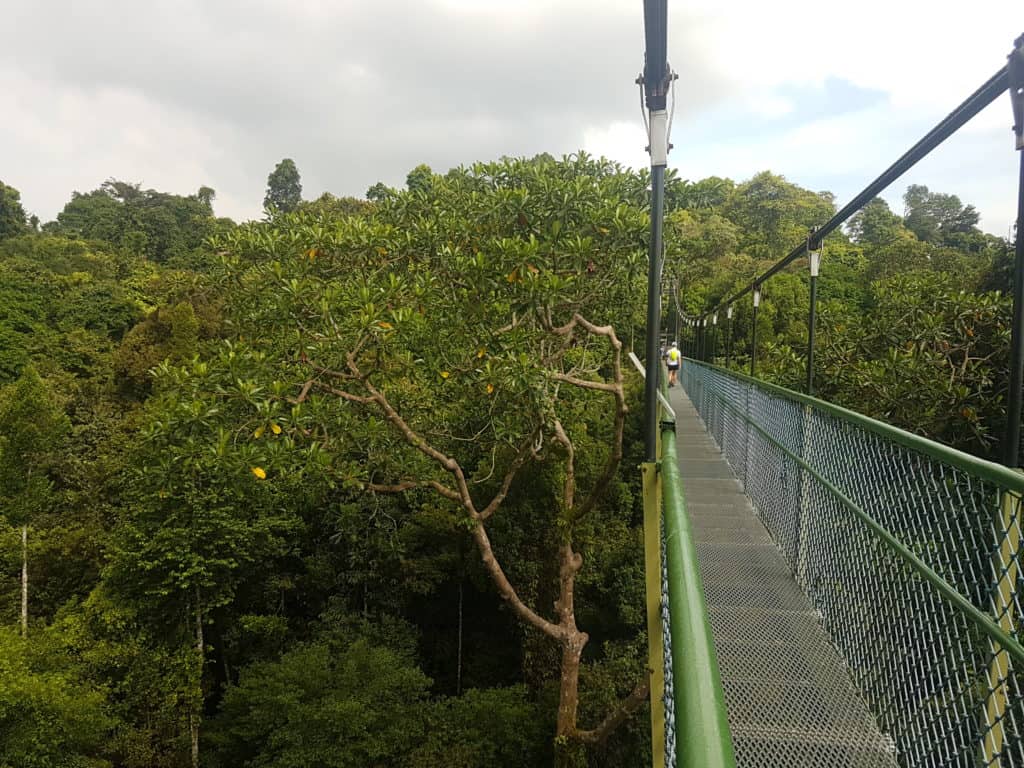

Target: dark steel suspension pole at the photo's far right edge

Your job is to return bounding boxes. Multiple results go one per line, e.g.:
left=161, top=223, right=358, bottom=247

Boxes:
left=1002, top=35, right=1024, bottom=467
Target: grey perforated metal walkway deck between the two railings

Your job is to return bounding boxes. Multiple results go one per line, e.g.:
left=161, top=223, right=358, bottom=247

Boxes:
left=670, top=388, right=897, bottom=768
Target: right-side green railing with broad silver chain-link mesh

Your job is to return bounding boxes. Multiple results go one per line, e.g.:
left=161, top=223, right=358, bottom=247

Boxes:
left=681, top=359, right=1024, bottom=768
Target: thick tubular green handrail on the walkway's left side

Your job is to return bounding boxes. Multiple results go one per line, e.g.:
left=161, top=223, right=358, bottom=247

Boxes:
left=659, top=370, right=736, bottom=768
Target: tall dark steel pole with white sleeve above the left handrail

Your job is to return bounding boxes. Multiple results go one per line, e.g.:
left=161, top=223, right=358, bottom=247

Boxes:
left=641, top=0, right=672, bottom=462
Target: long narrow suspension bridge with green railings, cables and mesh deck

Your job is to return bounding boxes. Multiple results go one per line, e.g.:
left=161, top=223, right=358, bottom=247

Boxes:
left=635, top=0, right=1024, bottom=768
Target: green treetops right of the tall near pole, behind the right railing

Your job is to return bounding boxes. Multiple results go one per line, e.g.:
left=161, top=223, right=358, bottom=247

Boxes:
left=667, top=173, right=1013, bottom=458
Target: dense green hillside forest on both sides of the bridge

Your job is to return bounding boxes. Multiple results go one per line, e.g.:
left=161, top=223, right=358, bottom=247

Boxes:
left=0, top=153, right=1012, bottom=768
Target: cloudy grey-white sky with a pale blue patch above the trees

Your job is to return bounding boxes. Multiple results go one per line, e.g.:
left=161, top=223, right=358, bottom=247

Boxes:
left=0, top=0, right=1024, bottom=234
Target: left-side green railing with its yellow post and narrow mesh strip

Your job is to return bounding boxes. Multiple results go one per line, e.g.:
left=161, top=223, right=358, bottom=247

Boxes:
left=642, top=368, right=736, bottom=768
